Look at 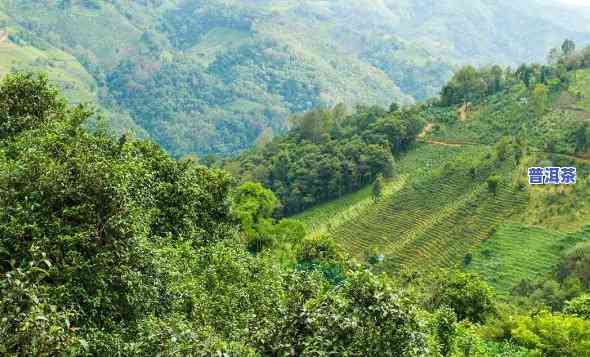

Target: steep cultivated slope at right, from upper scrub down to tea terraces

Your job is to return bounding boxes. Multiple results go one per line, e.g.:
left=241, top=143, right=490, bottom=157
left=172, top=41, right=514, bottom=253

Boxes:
left=295, top=65, right=590, bottom=293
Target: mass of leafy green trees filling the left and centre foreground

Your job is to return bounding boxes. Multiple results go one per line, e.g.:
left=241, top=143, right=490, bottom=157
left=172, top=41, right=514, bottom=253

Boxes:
left=0, top=74, right=440, bottom=355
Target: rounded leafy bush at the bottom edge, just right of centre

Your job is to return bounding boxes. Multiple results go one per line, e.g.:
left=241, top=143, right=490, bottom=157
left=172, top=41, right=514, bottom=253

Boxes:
left=302, top=271, right=426, bottom=356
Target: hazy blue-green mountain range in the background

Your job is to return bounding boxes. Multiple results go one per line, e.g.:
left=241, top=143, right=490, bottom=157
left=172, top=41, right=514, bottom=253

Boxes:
left=0, top=0, right=590, bottom=156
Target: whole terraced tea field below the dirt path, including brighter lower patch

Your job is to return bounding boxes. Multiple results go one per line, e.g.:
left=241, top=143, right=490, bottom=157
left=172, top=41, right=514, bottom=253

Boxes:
left=294, top=136, right=590, bottom=272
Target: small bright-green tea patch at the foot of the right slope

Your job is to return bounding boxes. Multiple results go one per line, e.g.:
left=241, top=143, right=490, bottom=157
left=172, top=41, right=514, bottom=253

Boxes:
left=468, top=224, right=590, bottom=293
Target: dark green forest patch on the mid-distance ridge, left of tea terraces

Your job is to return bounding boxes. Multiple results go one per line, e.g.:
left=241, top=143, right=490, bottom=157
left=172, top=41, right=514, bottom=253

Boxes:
left=234, top=106, right=422, bottom=215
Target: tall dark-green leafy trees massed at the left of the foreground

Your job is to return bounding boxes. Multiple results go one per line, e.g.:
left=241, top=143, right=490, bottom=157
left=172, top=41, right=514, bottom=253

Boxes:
left=0, top=74, right=240, bottom=355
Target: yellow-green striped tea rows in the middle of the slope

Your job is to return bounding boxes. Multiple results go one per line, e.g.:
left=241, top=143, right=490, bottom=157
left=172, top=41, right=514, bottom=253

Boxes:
left=331, top=163, right=527, bottom=270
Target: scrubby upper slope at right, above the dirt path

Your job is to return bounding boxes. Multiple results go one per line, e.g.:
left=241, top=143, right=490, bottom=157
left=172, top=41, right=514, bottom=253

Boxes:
left=430, top=41, right=590, bottom=156
